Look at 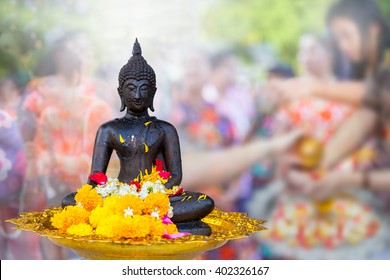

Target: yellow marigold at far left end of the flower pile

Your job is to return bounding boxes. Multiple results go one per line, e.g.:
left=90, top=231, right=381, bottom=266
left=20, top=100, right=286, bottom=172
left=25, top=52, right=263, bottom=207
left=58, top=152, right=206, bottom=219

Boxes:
left=50, top=206, right=90, bottom=231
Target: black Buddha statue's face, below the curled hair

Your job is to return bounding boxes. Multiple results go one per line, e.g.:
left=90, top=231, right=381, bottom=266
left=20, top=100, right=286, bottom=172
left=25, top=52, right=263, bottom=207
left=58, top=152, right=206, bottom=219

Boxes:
left=119, top=79, right=156, bottom=113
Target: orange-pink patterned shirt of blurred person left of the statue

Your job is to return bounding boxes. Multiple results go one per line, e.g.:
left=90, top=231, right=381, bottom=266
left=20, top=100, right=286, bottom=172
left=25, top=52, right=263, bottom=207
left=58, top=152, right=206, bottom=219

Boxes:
left=24, top=77, right=112, bottom=201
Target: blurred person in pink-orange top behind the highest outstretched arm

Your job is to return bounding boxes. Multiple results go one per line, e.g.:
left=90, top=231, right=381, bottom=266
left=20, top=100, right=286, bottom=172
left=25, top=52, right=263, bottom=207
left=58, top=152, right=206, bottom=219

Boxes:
left=276, top=34, right=353, bottom=142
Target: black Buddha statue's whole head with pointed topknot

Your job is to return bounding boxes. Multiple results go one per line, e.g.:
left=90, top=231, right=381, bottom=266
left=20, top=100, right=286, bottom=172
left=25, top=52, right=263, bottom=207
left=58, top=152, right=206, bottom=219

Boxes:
left=118, top=39, right=157, bottom=115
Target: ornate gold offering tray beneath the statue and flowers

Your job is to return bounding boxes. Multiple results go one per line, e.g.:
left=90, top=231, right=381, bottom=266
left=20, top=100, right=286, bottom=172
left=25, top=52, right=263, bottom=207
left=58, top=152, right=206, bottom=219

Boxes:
left=8, top=208, right=265, bottom=260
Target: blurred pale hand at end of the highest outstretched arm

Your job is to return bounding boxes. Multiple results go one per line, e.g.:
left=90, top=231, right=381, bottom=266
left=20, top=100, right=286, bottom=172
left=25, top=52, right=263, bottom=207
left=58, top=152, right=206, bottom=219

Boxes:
left=273, top=77, right=317, bottom=102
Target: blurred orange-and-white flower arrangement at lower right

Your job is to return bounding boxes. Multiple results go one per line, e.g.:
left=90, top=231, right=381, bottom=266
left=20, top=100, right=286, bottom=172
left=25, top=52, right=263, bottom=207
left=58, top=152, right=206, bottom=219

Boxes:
left=262, top=197, right=380, bottom=249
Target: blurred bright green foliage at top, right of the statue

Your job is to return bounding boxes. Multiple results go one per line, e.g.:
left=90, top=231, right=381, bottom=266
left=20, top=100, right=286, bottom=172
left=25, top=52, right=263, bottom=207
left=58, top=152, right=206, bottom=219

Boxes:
left=204, top=0, right=390, bottom=62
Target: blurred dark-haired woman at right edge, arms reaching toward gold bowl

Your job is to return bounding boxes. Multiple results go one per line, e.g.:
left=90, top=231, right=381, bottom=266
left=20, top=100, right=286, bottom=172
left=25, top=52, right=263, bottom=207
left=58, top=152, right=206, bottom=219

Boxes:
left=287, top=0, right=390, bottom=258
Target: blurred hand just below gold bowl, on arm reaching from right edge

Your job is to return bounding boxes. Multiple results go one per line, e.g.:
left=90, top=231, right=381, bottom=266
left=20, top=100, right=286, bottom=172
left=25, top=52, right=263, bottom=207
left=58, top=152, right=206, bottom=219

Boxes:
left=284, top=169, right=316, bottom=195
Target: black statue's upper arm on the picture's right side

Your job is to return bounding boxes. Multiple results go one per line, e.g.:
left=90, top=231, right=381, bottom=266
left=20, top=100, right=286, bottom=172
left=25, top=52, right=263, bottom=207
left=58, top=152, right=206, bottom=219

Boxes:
left=163, top=124, right=183, bottom=188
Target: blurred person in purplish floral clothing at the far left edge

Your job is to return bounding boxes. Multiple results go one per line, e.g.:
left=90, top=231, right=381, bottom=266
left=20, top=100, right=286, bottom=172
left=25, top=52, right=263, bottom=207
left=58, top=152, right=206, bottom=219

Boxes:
left=0, top=80, right=45, bottom=259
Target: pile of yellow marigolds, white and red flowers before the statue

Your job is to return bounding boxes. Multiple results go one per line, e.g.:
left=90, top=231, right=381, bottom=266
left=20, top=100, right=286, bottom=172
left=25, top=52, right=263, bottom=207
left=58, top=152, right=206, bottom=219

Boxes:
left=51, top=160, right=188, bottom=240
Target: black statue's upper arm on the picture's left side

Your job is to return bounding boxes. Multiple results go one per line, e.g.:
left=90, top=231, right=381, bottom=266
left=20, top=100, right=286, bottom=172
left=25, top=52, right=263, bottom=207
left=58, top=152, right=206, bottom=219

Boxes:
left=88, top=125, right=112, bottom=183
